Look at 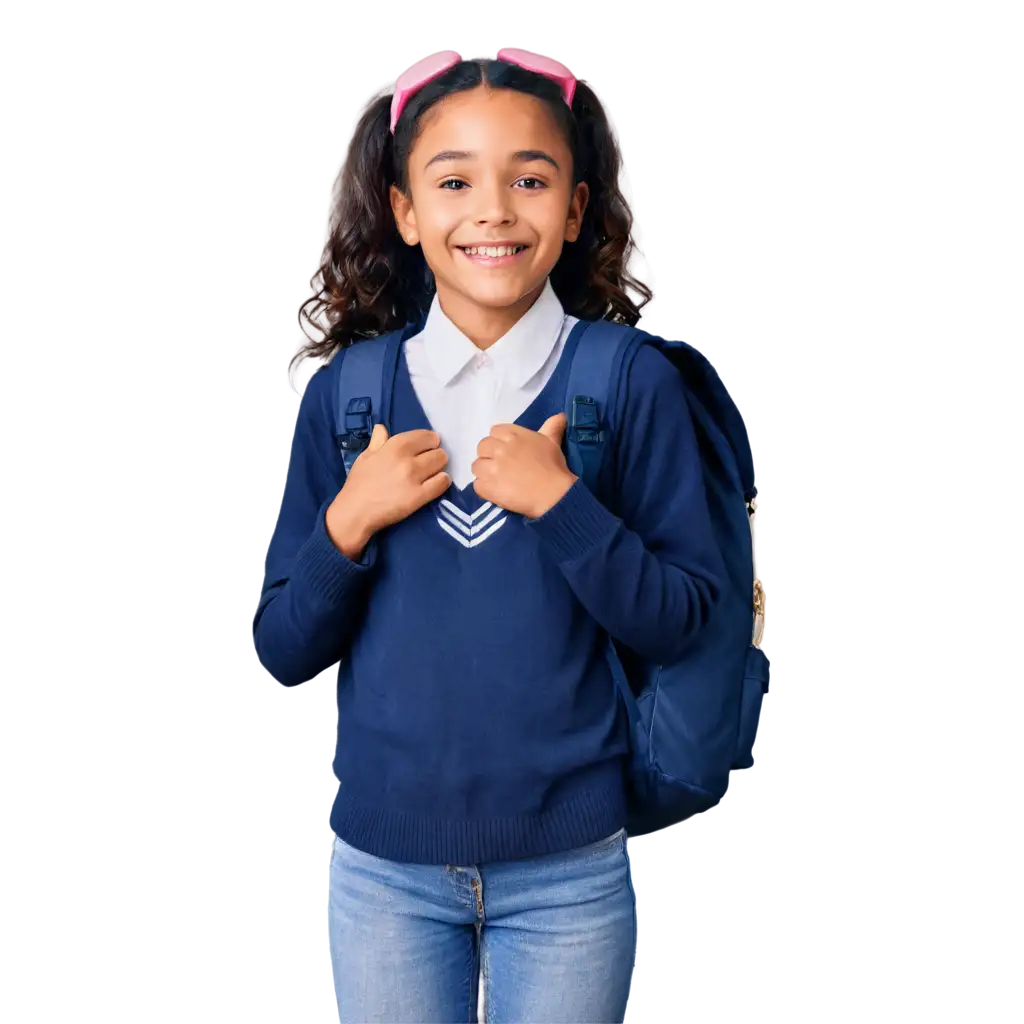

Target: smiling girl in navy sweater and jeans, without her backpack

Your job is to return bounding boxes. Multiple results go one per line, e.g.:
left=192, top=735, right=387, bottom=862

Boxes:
left=250, top=51, right=722, bottom=1024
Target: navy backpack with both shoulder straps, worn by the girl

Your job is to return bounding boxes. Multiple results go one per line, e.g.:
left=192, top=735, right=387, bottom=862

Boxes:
left=335, top=321, right=768, bottom=834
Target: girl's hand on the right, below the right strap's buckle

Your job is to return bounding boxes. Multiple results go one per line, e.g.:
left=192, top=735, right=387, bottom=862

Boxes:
left=471, top=413, right=577, bottom=519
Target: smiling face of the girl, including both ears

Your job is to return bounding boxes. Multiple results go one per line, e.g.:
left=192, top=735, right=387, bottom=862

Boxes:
left=391, top=86, right=587, bottom=340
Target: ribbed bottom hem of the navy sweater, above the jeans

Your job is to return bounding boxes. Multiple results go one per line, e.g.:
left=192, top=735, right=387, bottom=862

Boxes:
left=330, top=760, right=627, bottom=866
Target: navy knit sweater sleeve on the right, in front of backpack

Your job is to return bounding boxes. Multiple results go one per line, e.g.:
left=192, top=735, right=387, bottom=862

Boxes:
left=527, top=345, right=725, bottom=665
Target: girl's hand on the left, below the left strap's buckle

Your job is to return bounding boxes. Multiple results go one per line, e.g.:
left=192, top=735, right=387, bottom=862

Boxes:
left=326, top=423, right=452, bottom=559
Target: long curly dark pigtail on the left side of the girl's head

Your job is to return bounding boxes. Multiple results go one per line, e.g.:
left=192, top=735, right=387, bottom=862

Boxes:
left=285, top=91, right=427, bottom=392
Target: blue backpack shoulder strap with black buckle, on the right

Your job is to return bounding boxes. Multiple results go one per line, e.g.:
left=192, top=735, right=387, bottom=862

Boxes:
left=565, top=321, right=644, bottom=492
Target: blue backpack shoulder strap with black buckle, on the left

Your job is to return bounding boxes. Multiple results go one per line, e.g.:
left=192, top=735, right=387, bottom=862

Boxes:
left=334, top=331, right=403, bottom=474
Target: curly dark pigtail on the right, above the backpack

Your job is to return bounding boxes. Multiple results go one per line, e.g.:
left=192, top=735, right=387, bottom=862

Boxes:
left=551, top=80, right=647, bottom=325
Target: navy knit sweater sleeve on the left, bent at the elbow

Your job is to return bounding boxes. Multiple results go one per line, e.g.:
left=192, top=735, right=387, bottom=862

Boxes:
left=248, top=368, right=376, bottom=687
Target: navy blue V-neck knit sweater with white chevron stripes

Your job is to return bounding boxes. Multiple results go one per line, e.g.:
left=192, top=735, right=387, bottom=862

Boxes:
left=249, top=329, right=723, bottom=865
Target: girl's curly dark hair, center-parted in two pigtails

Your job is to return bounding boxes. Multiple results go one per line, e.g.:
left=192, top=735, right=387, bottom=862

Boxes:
left=286, top=56, right=646, bottom=391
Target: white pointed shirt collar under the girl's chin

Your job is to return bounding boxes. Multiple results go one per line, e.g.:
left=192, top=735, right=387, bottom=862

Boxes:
left=423, top=281, right=565, bottom=387
